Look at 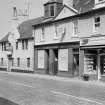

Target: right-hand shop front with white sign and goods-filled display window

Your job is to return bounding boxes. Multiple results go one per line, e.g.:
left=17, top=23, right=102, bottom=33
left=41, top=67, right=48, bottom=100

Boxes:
left=79, top=36, right=105, bottom=80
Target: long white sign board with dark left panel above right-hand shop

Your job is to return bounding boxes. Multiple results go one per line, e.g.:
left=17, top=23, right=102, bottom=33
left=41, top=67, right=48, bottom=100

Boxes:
left=80, top=35, right=105, bottom=46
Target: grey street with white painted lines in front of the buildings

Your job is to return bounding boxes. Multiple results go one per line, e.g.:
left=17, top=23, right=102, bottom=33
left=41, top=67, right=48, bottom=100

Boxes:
left=0, top=72, right=105, bottom=105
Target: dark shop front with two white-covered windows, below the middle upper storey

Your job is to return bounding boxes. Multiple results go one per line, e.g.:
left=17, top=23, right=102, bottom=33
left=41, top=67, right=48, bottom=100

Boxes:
left=35, top=42, right=79, bottom=77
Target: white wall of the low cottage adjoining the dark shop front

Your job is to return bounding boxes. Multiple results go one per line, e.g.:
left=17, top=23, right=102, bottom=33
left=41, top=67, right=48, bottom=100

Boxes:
left=12, top=40, right=34, bottom=71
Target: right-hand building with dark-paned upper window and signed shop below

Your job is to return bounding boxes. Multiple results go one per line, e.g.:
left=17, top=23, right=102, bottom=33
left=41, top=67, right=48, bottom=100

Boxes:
left=79, top=0, right=105, bottom=80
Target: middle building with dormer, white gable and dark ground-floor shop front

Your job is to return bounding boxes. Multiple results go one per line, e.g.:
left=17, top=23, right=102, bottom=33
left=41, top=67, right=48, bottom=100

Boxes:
left=33, top=0, right=79, bottom=77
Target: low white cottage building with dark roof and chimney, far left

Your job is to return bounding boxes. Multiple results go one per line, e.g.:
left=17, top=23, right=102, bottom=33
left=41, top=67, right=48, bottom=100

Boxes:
left=0, top=1, right=34, bottom=72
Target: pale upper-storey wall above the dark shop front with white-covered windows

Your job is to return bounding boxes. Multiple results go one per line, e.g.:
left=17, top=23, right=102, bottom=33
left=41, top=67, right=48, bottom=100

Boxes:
left=35, top=20, right=78, bottom=45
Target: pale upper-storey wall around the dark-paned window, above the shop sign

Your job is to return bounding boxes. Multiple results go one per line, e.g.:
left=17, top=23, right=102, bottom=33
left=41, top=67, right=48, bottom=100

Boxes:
left=78, top=13, right=105, bottom=37
